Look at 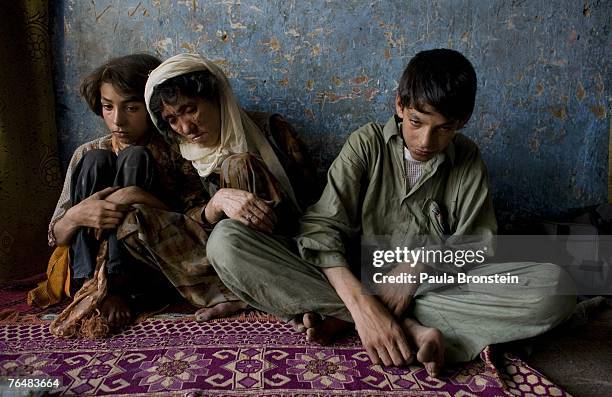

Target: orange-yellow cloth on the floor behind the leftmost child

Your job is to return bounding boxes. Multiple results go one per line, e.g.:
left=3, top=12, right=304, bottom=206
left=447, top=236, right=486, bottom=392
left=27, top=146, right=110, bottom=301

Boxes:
left=28, top=246, right=70, bottom=307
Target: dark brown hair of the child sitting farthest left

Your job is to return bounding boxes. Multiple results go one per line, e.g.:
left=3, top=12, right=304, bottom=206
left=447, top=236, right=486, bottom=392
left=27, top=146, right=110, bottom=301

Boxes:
left=80, top=54, right=161, bottom=116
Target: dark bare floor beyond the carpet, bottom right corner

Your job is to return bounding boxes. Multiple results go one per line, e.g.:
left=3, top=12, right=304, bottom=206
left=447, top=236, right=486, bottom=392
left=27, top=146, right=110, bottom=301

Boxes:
left=524, top=297, right=612, bottom=397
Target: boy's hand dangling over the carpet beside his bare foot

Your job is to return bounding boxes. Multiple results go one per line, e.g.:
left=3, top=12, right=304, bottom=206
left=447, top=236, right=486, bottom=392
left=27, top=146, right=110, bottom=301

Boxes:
left=351, top=295, right=413, bottom=366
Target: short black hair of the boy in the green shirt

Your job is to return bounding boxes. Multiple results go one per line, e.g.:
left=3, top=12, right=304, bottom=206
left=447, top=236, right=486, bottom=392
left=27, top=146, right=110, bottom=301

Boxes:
left=397, top=48, right=477, bottom=122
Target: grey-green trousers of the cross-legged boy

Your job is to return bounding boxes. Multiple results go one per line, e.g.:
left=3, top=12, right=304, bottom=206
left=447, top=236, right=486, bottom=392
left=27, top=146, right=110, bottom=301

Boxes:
left=207, top=220, right=576, bottom=362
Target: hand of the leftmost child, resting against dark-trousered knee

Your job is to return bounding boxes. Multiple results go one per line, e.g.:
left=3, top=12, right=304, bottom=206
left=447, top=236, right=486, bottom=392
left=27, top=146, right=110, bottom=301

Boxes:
left=69, top=187, right=129, bottom=229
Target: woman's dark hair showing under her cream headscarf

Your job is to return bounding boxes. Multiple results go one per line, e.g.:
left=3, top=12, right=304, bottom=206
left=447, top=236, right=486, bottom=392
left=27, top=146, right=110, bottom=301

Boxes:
left=149, top=70, right=219, bottom=141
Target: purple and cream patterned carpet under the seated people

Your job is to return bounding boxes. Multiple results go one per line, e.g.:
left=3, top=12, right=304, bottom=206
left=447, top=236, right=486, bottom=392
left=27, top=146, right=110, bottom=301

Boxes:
left=0, top=276, right=567, bottom=397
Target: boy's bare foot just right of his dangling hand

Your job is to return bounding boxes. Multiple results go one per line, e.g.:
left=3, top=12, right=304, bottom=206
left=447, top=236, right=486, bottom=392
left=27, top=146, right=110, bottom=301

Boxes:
left=401, top=318, right=444, bottom=378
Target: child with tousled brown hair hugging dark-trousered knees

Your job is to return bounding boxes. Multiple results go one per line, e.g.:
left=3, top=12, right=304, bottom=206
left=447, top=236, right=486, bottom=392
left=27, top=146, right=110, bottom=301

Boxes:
left=49, top=54, right=244, bottom=336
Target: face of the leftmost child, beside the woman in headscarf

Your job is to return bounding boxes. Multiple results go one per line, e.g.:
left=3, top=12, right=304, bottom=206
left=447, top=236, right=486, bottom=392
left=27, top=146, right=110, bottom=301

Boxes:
left=100, top=83, right=149, bottom=145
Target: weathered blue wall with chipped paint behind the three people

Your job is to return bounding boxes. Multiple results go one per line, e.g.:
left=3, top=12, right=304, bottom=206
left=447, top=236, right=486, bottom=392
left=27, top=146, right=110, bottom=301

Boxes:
left=53, top=0, right=612, bottom=221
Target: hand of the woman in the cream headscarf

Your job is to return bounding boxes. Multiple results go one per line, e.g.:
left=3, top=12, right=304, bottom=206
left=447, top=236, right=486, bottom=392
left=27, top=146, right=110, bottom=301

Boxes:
left=209, top=188, right=276, bottom=233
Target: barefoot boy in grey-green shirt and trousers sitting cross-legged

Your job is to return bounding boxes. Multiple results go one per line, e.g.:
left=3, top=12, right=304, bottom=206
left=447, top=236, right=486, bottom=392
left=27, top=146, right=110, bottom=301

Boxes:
left=208, top=49, right=575, bottom=377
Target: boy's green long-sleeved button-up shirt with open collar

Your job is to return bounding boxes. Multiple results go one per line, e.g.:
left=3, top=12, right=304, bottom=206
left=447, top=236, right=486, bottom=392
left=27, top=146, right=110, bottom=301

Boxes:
left=296, top=117, right=497, bottom=272
